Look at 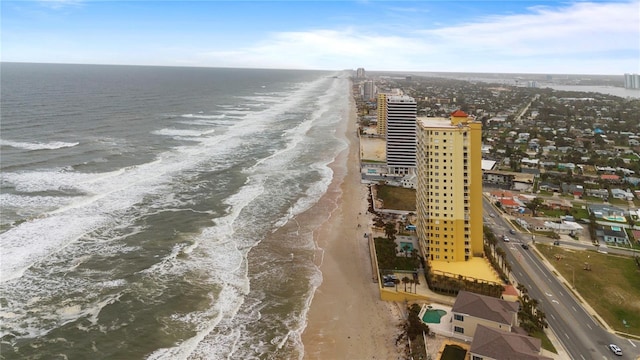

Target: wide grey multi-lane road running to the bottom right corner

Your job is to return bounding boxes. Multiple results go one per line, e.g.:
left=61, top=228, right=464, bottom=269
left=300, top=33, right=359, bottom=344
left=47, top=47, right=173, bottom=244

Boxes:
left=483, top=199, right=640, bottom=360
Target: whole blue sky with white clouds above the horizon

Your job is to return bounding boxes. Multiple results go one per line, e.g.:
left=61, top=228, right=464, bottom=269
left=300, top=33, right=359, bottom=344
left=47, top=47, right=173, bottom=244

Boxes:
left=0, top=0, right=640, bottom=75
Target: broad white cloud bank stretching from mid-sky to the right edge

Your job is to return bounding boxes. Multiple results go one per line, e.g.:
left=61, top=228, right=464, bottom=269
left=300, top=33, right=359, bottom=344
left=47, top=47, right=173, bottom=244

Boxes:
left=200, top=1, right=640, bottom=73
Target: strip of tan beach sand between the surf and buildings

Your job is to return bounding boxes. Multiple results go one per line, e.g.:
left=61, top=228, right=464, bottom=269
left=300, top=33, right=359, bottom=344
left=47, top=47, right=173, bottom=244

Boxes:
left=302, top=94, right=402, bottom=359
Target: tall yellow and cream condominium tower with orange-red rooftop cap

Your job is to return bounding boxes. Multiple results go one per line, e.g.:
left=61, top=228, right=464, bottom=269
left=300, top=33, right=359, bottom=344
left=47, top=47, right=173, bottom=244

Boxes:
left=416, top=110, right=483, bottom=262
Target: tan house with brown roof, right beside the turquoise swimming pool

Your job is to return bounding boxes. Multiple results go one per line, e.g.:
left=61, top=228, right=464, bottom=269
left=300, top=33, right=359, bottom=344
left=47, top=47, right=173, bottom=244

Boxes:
left=451, top=291, right=519, bottom=341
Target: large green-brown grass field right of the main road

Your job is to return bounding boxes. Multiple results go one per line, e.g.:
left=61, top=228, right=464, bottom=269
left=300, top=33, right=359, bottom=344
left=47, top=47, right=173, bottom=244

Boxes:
left=536, top=244, right=640, bottom=336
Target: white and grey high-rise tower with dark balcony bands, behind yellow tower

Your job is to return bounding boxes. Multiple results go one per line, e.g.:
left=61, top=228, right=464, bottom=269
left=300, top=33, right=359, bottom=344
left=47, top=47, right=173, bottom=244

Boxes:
left=386, top=95, right=417, bottom=175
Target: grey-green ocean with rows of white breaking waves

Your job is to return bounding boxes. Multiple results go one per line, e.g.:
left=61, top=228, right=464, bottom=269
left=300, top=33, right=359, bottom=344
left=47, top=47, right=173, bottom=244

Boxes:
left=0, top=63, right=352, bottom=359
